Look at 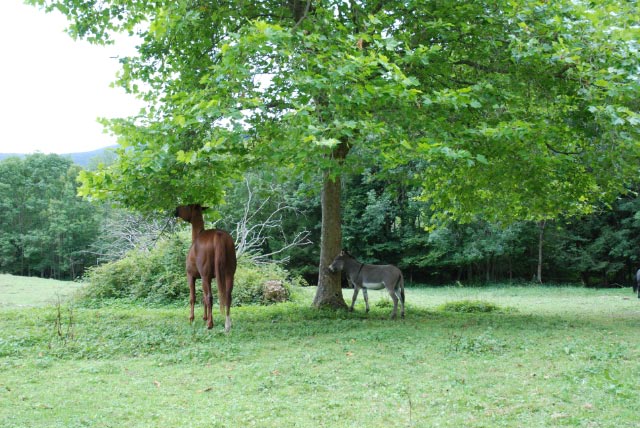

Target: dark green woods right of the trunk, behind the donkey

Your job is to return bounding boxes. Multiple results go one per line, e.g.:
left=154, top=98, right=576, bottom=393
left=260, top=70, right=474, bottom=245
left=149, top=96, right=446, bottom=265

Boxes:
left=314, top=169, right=640, bottom=287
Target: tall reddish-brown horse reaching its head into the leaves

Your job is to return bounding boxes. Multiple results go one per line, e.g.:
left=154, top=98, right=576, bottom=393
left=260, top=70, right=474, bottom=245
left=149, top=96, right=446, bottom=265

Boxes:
left=175, top=204, right=237, bottom=332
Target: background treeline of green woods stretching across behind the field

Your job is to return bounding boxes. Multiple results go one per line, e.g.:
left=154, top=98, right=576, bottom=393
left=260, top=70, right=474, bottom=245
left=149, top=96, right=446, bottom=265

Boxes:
left=0, top=154, right=640, bottom=286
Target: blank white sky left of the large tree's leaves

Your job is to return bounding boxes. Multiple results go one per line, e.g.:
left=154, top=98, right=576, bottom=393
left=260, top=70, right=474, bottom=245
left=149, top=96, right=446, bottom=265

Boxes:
left=0, top=0, right=142, bottom=153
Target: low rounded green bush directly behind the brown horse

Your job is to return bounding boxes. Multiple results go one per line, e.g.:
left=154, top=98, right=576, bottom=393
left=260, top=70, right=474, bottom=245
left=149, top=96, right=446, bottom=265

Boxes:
left=83, top=235, right=299, bottom=306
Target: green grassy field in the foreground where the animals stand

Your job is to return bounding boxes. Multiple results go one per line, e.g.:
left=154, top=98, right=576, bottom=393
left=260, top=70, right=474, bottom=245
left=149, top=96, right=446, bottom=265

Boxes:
left=0, top=280, right=640, bottom=427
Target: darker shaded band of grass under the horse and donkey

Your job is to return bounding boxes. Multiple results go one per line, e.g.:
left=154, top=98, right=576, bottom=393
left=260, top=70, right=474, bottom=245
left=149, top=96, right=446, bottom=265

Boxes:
left=0, top=290, right=637, bottom=359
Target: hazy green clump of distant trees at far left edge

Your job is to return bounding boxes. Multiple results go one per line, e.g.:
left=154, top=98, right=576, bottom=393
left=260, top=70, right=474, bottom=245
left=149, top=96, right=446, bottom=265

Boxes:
left=0, top=154, right=100, bottom=279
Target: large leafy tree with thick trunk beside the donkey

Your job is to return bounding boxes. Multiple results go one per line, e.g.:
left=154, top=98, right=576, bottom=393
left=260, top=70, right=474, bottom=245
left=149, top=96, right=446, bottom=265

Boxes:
left=30, top=0, right=639, bottom=306
